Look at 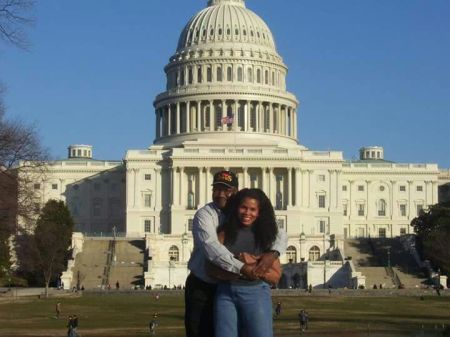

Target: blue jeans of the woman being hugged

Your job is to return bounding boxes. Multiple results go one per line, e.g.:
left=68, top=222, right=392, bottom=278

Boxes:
left=214, top=282, right=273, bottom=337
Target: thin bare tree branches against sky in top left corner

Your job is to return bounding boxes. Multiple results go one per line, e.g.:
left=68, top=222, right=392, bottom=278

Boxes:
left=0, top=0, right=35, bottom=49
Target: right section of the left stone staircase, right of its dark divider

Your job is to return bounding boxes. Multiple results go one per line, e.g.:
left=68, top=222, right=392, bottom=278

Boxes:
left=109, top=240, right=145, bottom=289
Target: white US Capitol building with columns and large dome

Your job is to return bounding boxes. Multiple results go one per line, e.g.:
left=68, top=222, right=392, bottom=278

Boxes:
left=25, top=0, right=450, bottom=285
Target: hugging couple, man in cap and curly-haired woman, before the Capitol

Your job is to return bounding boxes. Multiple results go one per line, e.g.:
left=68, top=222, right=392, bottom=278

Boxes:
left=185, top=171, right=287, bottom=337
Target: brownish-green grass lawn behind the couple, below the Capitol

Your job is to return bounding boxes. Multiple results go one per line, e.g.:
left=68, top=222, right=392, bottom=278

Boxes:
left=0, top=292, right=450, bottom=337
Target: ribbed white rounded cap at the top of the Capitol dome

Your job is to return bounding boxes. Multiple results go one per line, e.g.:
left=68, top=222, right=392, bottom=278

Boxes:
left=177, top=0, right=275, bottom=52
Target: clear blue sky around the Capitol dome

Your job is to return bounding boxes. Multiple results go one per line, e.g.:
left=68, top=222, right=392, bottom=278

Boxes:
left=0, top=0, right=450, bottom=168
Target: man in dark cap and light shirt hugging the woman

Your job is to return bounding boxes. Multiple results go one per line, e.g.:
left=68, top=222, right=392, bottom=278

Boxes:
left=185, top=171, right=287, bottom=337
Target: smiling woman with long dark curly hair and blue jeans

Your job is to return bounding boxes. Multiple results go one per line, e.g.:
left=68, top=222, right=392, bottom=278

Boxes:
left=214, top=189, right=278, bottom=337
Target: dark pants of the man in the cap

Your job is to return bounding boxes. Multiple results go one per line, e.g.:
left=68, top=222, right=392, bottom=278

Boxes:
left=184, top=273, right=216, bottom=337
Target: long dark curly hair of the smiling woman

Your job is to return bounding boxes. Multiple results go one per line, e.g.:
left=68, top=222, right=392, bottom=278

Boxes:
left=219, top=188, right=278, bottom=252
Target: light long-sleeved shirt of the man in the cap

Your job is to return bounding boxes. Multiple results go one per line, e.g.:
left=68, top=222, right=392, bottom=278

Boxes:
left=188, top=202, right=287, bottom=283
